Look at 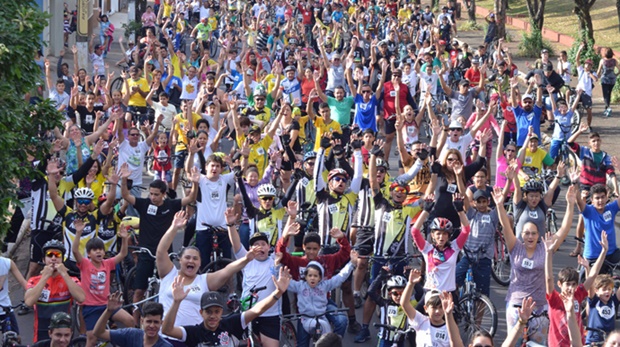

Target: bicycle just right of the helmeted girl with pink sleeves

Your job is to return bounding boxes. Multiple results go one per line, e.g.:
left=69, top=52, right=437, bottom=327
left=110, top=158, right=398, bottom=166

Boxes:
left=454, top=247, right=498, bottom=341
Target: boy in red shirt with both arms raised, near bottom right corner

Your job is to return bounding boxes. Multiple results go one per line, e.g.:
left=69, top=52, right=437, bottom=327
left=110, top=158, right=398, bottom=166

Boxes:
left=544, top=231, right=615, bottom=346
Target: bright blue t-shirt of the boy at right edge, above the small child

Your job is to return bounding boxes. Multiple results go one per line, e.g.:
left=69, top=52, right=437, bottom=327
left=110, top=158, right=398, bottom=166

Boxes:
left=581, top=200, right=619, bottom=259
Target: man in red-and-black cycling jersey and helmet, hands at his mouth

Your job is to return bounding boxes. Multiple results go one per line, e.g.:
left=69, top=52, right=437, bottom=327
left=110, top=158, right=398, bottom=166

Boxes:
left=24, top=239, right=86, bottom=342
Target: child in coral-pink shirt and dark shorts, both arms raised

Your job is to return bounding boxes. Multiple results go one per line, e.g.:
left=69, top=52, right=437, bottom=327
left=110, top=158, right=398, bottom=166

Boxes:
left=71, top=219, right=134, bottom=347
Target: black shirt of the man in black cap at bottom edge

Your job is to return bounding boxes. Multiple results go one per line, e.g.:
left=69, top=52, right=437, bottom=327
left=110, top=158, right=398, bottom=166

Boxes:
left=183, top=313, right=243, bottom=347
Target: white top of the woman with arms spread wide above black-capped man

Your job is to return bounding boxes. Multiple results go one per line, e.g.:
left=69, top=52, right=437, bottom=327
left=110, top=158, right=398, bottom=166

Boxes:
left=159, top=266, right=209, bottom=326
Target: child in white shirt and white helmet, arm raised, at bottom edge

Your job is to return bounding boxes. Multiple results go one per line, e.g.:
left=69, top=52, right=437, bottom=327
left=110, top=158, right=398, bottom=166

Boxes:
left=400, top=269, right=454, bottom=347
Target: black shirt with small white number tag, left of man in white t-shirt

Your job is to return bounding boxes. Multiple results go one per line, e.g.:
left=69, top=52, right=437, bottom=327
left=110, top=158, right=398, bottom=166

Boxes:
left=133, top=198, right=182, bottom=254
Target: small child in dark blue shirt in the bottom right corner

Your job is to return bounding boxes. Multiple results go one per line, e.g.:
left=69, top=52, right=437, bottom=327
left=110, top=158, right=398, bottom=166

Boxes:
left=586, top=274, right=620, bottom=345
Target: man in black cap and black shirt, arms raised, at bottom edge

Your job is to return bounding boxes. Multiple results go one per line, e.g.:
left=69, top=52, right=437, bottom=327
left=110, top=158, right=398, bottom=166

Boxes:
left=162, top=274, right=291, bottom=347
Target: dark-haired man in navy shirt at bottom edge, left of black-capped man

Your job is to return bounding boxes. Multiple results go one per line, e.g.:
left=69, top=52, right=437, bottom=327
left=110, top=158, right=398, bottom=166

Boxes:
left=93, top=290, right=171, bottom=347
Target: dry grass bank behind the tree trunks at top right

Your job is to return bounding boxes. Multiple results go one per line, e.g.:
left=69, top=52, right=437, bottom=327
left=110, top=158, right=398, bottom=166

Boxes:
left=476, top=0, right=620, bottom=49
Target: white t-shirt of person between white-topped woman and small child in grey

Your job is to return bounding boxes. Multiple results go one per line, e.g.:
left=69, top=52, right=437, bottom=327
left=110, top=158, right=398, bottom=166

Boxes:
left=235, top=246, right=282, bottom=317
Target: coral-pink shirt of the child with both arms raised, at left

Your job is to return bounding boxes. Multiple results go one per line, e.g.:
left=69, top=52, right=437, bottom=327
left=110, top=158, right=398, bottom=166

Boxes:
left=77, top=258, right=115, bottom=306
